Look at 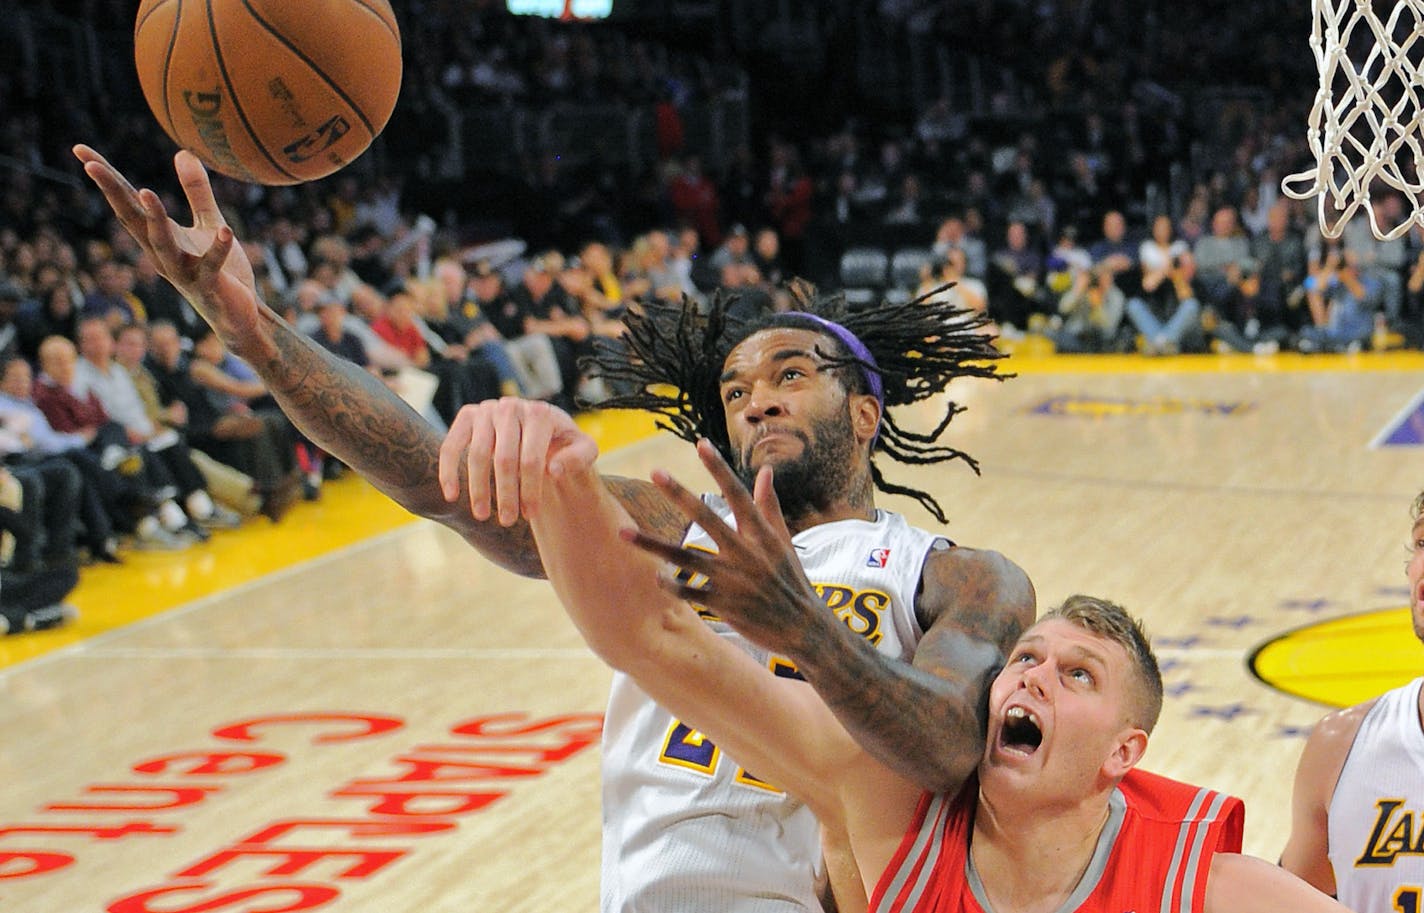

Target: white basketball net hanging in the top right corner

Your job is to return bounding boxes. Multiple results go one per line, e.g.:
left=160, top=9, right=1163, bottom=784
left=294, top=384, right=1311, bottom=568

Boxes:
left=1280, top=0, right=1424, bottom=239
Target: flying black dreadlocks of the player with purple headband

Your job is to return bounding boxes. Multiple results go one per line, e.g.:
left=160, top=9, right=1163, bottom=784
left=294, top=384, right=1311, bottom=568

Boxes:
left=587, top=282, right=1011, bottom=523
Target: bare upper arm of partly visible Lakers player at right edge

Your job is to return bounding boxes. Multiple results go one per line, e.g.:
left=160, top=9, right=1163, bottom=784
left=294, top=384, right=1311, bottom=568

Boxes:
left=1280, top=701, right=1374, bottom=894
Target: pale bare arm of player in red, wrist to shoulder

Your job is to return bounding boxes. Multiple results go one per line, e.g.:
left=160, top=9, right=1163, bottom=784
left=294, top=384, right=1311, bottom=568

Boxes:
left=531, top=452, right=920, bottom=894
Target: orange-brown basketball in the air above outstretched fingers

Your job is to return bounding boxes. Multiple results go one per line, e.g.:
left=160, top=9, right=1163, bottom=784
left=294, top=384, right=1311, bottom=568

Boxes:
left=134, top=0, right=400, bottom=184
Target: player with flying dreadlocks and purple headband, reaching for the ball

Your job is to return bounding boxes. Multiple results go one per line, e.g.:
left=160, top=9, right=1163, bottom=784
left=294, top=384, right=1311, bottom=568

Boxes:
left=75, top=135, right=1034, bottom=913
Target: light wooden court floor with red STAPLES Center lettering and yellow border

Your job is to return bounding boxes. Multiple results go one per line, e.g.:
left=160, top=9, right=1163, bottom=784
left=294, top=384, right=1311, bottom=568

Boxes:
left=0, top=353, right=1424, bottom=913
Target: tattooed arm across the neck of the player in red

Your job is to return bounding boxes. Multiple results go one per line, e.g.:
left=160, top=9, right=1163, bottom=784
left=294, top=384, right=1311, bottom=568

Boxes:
left=639, top=442, right=1034, bottom=792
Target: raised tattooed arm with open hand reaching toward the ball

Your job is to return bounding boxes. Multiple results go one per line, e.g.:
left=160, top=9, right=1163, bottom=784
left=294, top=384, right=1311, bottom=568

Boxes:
left=74, top=145, right=682, bottom=577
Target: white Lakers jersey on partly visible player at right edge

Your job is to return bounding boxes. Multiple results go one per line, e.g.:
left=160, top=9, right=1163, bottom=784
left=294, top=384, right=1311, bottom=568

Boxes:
left=1329, top=678, right=1424, bottom=913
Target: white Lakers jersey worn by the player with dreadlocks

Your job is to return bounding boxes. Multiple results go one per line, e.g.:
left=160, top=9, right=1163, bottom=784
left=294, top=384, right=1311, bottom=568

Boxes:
left=602, top=496, right=950, bottom=913
